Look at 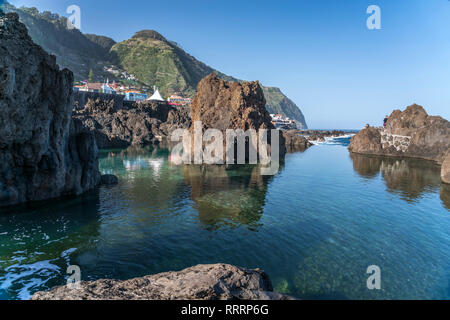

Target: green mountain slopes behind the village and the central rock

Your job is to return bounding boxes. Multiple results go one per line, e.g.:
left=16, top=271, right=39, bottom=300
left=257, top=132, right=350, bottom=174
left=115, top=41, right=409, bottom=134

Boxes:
left=2, top=3, right=307, bottom=128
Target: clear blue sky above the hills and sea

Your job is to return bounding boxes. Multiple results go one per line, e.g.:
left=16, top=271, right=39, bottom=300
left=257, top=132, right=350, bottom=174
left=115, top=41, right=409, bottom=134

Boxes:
left=5, top=0, right=450, bottom=128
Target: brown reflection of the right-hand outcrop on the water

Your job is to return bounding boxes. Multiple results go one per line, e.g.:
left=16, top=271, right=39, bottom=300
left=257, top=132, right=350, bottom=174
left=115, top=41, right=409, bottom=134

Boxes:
left=350, top=154, right=440, bottom=199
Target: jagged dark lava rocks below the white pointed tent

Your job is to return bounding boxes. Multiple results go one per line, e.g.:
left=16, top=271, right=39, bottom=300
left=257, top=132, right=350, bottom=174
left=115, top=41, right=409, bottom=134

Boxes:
left=73, top=97, right=190, bottom=148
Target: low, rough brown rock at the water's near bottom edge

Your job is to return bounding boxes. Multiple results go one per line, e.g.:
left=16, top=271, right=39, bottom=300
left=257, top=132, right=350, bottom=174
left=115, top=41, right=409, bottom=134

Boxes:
left=32, top=264, right=292, bottom=300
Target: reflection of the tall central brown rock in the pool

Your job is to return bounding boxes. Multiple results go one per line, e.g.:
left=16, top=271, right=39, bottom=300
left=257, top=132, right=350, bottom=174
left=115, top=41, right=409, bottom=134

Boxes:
left=183, top=165, right=271, bottom=229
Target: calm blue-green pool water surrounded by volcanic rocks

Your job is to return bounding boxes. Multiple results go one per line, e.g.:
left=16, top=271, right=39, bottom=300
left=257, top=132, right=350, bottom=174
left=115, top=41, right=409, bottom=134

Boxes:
left=0, top=139, right=450, bottom=299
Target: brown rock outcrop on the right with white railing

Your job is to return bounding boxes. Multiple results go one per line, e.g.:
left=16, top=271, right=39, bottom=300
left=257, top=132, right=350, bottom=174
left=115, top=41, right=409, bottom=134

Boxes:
left=349, top=105, right=450, bottom=164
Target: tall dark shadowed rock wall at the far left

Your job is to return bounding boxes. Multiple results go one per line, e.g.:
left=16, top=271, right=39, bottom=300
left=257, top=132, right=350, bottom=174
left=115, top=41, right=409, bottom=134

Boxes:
left=0, top=13, right=100, bottom=206
